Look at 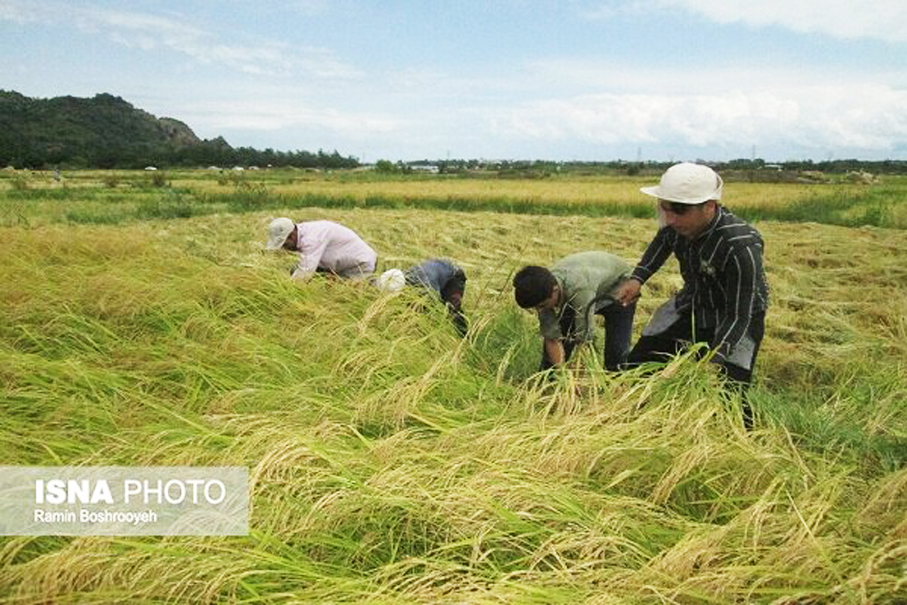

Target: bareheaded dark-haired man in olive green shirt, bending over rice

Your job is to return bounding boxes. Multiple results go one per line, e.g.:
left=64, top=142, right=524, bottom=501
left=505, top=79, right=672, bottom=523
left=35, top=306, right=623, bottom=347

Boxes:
left=513, top=252, right=636, bottom=370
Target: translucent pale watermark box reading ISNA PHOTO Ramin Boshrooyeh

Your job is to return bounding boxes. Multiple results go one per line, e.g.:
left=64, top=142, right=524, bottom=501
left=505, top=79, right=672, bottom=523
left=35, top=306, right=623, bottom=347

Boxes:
left=0, top=466, right=249, bottom=536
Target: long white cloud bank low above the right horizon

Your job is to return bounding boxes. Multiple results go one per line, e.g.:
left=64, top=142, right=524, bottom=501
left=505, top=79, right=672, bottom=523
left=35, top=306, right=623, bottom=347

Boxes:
left=488, top=85, right=907, bottom=151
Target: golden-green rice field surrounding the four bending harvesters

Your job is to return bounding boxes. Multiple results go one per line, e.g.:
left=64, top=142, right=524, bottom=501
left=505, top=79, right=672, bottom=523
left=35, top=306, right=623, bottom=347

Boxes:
left=0, top=173, right=907, bottom=604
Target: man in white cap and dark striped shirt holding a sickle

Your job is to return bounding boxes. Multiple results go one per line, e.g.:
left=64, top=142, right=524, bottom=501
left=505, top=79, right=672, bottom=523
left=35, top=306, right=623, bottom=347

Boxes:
left=615, top=163, right=768, bottom=426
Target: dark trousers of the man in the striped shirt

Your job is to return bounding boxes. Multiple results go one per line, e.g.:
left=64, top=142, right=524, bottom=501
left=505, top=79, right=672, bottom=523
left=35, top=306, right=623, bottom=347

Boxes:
left=624, top=311, right=765, bottom=428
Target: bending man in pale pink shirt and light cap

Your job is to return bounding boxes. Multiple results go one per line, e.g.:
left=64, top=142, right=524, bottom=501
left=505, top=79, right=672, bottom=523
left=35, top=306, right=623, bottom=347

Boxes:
left=265, top=217, right=378, bottom=279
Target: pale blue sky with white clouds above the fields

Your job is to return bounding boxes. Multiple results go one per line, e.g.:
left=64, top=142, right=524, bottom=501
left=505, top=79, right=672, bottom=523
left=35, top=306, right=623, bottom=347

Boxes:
left=0, top=0, right=907, bottom=162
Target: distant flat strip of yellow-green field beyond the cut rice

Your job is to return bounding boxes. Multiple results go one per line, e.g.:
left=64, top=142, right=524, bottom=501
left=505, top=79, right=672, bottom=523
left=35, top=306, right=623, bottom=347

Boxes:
left=0, top=170, right=907, bottom=229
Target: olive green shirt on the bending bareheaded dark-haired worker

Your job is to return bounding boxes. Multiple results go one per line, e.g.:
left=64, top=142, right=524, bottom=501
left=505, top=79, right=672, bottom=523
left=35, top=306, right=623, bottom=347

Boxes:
left=539, top=252, right=633, bottom=342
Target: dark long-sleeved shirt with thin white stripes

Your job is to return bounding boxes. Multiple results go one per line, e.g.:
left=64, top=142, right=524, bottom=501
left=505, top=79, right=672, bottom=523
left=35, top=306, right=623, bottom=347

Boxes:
left=632, top=204, right=768, bottom=357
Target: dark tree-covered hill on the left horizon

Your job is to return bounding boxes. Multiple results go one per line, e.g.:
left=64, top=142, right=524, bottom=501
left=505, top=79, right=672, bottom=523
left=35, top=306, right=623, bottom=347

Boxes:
left=0, top=90, right=358, bottom=168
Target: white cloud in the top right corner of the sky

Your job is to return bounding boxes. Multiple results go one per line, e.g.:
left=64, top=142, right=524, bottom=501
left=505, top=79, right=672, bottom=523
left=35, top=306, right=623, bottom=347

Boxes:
left=660, top=0, right=907, bottom=44
